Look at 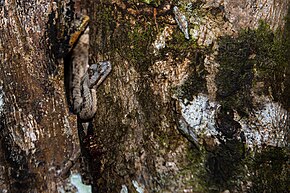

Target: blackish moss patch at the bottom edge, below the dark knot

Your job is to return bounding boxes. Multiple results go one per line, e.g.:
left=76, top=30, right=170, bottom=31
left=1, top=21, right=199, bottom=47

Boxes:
left=205, top=139, right=245, bottom=193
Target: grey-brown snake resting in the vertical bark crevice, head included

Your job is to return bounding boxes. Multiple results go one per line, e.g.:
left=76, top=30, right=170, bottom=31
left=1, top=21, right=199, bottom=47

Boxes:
left=70, top=27, right=112, bottom=120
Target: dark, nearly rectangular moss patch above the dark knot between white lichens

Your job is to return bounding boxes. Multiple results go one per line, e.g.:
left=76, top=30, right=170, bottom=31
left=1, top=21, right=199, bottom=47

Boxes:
left=216, top=31, right=255, bottom=116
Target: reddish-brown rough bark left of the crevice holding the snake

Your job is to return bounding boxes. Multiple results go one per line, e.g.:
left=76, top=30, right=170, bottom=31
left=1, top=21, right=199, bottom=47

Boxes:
left=0, top=0, right=79, bottom=192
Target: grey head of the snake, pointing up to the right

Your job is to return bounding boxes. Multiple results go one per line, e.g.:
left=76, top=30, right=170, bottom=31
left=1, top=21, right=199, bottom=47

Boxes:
left=88, top=61, right=112, bottom=88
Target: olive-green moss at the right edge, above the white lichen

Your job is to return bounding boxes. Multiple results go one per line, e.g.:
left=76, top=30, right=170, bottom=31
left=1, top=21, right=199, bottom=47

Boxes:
left=254, top=21, right=290, bottom=109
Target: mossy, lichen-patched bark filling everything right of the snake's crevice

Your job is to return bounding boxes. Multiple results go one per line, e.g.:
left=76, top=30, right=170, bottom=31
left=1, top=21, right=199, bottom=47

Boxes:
left=87, top=0, right=289, bottom=192
